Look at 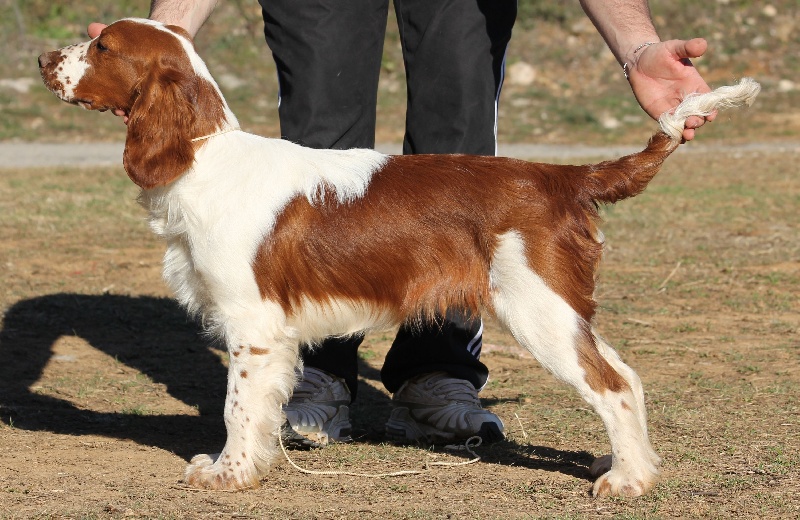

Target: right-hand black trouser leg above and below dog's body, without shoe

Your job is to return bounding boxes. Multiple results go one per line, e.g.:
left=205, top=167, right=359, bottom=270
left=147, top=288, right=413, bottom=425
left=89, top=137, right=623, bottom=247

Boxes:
left=382, top=0, right=516, bottom=391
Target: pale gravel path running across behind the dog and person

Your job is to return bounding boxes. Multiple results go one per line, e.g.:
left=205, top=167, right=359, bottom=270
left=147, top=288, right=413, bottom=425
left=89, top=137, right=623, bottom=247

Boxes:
left=0, top=141, right=800, bottom=168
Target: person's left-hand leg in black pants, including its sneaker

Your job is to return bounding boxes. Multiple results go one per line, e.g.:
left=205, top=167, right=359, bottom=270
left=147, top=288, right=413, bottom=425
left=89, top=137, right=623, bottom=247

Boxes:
left=260, top=0, right=388, bottom=444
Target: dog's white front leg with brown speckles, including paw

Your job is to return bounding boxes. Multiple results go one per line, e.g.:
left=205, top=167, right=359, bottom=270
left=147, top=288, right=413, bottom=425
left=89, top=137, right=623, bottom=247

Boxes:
left=184, top=339, right=298, bottom=490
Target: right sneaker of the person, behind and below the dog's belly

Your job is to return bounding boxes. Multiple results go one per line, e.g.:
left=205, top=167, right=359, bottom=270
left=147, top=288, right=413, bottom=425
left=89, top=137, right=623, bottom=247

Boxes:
left=386, top=372, right=505, bottom=444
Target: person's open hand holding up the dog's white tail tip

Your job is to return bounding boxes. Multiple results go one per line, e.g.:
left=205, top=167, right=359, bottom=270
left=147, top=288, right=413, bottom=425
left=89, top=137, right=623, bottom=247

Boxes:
left=628, top=38, right=717, bottom=141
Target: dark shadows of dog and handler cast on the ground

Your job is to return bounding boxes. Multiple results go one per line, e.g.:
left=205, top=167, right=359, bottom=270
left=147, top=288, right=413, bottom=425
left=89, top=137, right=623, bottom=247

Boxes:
left=0, top=293, right=593, bottom=478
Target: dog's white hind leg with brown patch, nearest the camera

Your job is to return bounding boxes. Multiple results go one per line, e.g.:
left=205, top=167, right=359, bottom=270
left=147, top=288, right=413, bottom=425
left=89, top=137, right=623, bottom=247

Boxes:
left=491, top=233, right=658, bottom=496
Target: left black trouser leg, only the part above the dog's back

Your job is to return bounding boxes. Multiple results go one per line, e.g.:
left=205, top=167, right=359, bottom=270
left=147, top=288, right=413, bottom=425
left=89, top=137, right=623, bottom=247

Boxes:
left=259, top=0, right=388, bottom=150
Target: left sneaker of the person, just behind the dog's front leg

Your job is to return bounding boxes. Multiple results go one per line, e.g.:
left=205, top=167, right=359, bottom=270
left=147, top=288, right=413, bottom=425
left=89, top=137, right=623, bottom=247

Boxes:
left=281, top=367, right=353, bottom=448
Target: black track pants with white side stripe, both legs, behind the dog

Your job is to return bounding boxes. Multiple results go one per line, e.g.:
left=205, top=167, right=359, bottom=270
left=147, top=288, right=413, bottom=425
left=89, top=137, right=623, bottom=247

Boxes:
left=259, top=0, right=517, bottom=398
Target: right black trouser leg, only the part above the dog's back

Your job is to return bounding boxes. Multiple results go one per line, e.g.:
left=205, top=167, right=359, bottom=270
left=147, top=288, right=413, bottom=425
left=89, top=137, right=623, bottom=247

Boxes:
left=395, top=0, right=517, bottom=155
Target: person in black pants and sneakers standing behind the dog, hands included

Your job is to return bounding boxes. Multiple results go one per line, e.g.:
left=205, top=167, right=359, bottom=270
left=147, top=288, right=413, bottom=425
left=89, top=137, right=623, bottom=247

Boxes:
left=89, top=0, right=715, bottom=446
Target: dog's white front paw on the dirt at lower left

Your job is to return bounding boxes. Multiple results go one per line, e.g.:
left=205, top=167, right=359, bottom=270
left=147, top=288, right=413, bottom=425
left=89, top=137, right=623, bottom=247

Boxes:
left=183, top=454, right=258, bottom=491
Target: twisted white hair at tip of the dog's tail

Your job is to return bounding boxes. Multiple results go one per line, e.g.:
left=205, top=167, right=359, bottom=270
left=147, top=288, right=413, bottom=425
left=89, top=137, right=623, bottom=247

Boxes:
left=658, top=78, right=761, bottom=141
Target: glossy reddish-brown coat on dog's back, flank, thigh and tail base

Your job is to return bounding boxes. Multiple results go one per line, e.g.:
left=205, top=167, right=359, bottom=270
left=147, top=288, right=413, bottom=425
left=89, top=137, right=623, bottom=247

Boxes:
left=254, top=128, right=678, bottom=328
